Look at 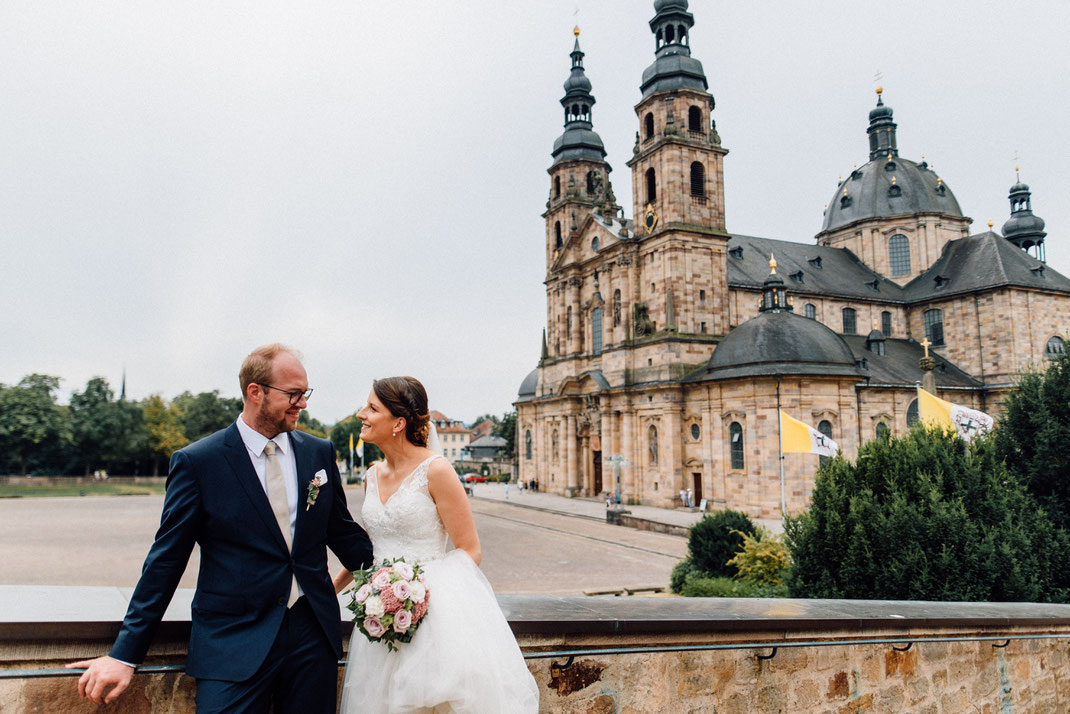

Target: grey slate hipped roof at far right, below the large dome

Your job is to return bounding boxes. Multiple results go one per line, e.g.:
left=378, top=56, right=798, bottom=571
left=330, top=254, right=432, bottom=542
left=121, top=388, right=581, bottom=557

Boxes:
left=903, top=231, right=1070, bottom=302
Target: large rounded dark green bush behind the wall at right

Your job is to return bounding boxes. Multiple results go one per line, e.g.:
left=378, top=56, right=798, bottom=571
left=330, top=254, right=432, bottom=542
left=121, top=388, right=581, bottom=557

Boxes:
left=784, top=425, right=1070, bottom=602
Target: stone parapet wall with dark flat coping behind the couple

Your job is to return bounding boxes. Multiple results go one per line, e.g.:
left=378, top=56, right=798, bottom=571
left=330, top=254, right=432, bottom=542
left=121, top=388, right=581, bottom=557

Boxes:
left=0, top=586, right=1070, bottom=714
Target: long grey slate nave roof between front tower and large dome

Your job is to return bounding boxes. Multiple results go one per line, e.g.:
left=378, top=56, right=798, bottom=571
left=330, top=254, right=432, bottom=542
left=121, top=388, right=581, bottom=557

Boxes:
left=728, top=236, right=903, bottom=302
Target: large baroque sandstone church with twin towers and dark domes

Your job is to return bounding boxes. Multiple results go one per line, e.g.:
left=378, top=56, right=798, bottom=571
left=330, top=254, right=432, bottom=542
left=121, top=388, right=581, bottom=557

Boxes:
left=516, top=0, right=1070, bottom=517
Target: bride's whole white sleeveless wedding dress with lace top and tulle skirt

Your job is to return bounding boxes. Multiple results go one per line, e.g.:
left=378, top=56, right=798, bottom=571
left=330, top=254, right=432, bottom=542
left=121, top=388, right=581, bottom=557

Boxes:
left=340, top=456, right=538, bottom=714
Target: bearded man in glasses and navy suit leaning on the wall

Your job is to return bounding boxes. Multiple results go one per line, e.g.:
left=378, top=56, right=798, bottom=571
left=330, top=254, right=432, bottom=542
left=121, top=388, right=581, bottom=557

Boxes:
left=67, top=344, right=371, bottom=714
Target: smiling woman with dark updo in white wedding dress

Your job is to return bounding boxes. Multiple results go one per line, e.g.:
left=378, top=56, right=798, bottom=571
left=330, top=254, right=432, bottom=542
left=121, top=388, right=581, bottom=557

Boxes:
left=334, top=377, right=538, bottom=714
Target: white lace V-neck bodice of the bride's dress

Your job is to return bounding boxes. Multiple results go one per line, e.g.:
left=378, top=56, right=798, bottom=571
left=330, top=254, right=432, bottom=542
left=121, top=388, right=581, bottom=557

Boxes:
left=361, top=456, right=447, bottom=562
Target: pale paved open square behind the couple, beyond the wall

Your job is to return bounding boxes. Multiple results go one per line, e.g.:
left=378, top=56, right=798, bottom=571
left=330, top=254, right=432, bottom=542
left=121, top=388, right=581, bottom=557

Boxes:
left=0, top=488, right=687, bottom=594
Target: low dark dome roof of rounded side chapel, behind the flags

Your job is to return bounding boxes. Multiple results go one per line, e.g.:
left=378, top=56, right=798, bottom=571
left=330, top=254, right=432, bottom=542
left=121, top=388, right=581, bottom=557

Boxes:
left=704, top=312, right=861, bottom=379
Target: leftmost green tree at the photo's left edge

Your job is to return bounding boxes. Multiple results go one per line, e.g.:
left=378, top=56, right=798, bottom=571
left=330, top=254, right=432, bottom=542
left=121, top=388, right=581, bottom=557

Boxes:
left=0, top=374, right=66, bottom=475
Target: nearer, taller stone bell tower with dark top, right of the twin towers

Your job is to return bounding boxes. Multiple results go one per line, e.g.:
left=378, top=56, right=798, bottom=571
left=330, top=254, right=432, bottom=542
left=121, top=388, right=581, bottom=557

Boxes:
left=628, top=0, right=728, bottom=234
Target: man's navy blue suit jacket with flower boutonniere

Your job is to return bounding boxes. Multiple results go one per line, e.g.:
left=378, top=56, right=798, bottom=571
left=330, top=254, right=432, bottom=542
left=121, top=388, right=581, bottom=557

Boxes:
left=110, top=424, right=371, bottom=682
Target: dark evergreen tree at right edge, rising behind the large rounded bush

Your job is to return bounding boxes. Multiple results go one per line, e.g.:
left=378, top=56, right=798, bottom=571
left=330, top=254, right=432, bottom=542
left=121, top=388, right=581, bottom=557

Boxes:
left=995, top=353, right=1070, bottom=530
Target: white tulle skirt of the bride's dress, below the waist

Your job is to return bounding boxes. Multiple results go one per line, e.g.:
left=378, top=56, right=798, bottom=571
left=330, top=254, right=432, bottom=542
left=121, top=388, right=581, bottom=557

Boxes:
left=340, top=550, right=538, bottom=714
